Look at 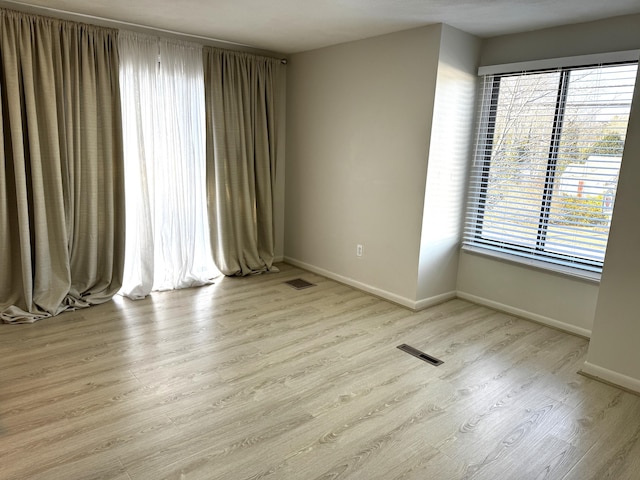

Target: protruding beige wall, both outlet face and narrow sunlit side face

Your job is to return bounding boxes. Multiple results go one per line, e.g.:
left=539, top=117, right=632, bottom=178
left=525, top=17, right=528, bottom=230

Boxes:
left=285, top=25, right=480, bottom=308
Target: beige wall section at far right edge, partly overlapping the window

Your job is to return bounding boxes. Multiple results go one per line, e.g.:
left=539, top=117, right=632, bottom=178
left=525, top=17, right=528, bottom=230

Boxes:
left=583, top=66, right=640, bottom=392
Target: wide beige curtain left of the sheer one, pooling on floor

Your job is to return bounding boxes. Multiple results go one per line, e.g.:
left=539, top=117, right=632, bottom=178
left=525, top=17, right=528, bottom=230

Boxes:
left=0, top=10, right=124, bottom=323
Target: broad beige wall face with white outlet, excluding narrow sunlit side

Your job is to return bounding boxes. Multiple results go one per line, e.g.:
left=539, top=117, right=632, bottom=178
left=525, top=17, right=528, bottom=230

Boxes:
left=285, top=25, right=442, bottom=306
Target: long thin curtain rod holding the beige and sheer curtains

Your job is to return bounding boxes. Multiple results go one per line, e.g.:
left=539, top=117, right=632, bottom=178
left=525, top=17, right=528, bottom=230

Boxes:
left=0, top=0, right=287, bottom=65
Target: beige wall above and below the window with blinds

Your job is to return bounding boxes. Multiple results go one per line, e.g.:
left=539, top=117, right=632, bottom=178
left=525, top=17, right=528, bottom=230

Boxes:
left=458, top=15, right=640, bottom=336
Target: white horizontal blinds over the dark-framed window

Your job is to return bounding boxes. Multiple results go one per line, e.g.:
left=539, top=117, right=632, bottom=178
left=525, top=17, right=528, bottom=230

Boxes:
left=464, top=62, right=637, bottom=272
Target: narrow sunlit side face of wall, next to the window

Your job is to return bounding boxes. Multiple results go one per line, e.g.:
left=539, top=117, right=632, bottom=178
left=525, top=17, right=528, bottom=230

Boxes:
left=416, top=25, right=480, bottom=307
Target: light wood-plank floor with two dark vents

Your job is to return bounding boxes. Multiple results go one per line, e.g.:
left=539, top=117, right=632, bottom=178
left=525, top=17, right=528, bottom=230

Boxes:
left=0, top=265, right=640, bottom=480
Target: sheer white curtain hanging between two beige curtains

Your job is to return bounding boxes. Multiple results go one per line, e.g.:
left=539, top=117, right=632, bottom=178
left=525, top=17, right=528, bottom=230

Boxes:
left=119, top=32, right=219, bottom=298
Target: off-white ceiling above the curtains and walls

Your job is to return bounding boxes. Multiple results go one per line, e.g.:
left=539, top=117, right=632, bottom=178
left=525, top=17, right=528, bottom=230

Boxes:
left=0, top=0, right=640, bottom=54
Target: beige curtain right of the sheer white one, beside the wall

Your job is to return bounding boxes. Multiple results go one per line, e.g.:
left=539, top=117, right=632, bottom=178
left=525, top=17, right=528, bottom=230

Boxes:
left=203, top=47, right=279, bottom=275
